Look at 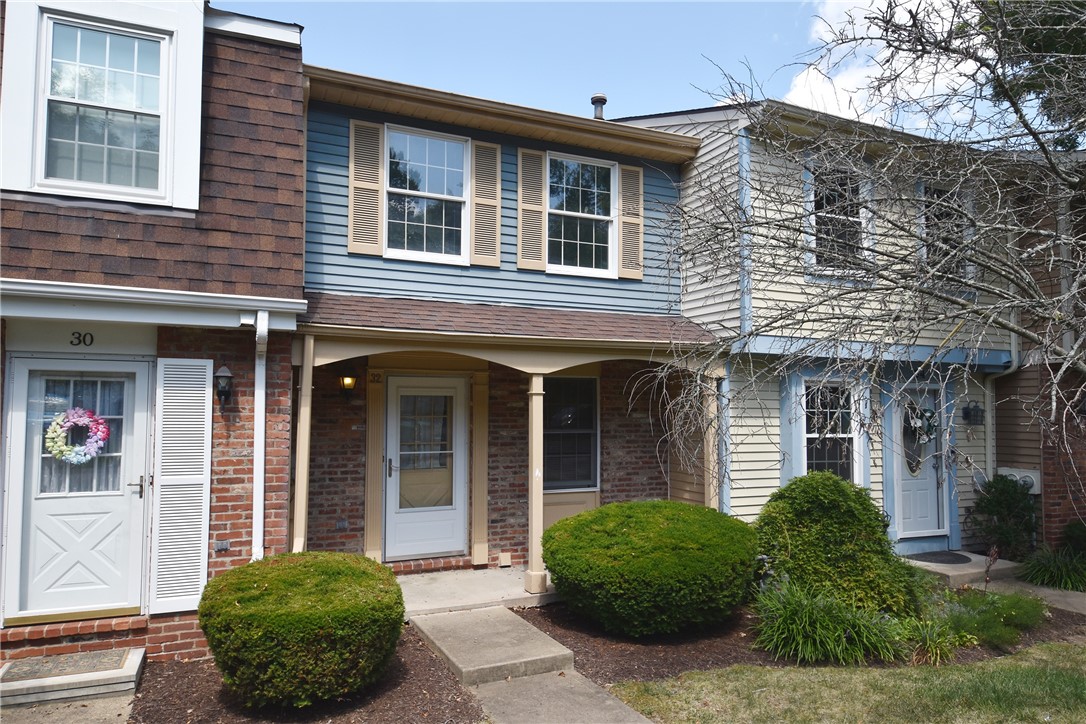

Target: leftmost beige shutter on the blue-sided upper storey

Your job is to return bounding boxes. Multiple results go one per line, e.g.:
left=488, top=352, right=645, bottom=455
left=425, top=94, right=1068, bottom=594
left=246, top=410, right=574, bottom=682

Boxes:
left=346, top=120, right=384, bottom=255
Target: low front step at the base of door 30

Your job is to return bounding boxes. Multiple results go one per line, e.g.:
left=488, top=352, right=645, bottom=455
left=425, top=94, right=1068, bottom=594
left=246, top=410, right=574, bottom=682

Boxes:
left=0, top=648, right=146, bottom=704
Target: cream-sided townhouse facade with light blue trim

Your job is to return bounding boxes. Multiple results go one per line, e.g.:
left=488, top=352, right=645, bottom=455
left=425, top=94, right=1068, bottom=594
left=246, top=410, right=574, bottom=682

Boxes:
left=622, top=101, right=1011, bottom=555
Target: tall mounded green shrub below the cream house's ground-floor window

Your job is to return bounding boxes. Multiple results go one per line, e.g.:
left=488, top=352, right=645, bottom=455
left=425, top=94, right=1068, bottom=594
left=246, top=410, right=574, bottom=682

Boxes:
left=755, top=472, right=925, bottom=618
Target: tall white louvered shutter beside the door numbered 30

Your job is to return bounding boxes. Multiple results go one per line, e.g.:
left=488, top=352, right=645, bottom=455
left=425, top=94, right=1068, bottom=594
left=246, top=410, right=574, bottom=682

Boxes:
left=150, top=359, right=212, bottom=613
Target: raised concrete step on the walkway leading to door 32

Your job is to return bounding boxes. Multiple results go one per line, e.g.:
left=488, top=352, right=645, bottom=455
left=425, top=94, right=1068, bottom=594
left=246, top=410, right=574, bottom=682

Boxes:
left=412, top=606, right=573, bottom=686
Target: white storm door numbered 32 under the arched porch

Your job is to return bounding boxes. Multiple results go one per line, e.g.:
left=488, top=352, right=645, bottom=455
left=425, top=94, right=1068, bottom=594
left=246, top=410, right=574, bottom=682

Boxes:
left=384, top=377, right=468, bottom=560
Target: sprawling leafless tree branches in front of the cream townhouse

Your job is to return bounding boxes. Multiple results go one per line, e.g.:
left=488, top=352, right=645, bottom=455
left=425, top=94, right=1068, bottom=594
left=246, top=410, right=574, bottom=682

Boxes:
left=655, top=0, right=1086, bottom=510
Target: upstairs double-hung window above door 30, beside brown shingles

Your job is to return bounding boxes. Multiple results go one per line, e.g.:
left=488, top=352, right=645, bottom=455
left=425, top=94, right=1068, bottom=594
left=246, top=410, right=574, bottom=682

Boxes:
left=43, top=18, right=166, bottom=192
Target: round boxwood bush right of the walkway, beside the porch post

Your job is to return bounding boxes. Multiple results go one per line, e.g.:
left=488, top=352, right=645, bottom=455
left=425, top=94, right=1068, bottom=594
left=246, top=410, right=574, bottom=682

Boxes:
left=543, top=500, right=756, bottom=636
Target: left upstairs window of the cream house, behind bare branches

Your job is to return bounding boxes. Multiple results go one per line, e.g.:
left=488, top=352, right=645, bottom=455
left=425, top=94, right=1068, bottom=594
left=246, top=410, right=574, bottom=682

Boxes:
left=807, top=168, right=871, bottom=272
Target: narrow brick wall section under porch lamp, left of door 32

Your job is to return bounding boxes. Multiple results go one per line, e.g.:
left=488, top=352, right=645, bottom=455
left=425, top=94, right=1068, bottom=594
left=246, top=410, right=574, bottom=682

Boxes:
left=306, top=366, right=369, bottom=552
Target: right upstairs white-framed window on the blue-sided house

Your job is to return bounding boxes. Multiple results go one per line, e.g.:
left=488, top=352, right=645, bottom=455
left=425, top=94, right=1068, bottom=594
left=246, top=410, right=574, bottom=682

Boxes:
left=546, top=154, right=618, bottom=277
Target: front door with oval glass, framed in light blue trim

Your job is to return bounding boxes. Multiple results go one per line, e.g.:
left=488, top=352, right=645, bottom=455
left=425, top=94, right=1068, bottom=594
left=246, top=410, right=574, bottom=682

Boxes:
left=898, top=390, right=947, bottom=537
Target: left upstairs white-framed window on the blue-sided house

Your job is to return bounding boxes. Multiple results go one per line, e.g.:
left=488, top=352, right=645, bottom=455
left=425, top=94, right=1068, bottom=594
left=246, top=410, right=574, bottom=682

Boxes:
left=384, top=127, right=468, bottom=264
